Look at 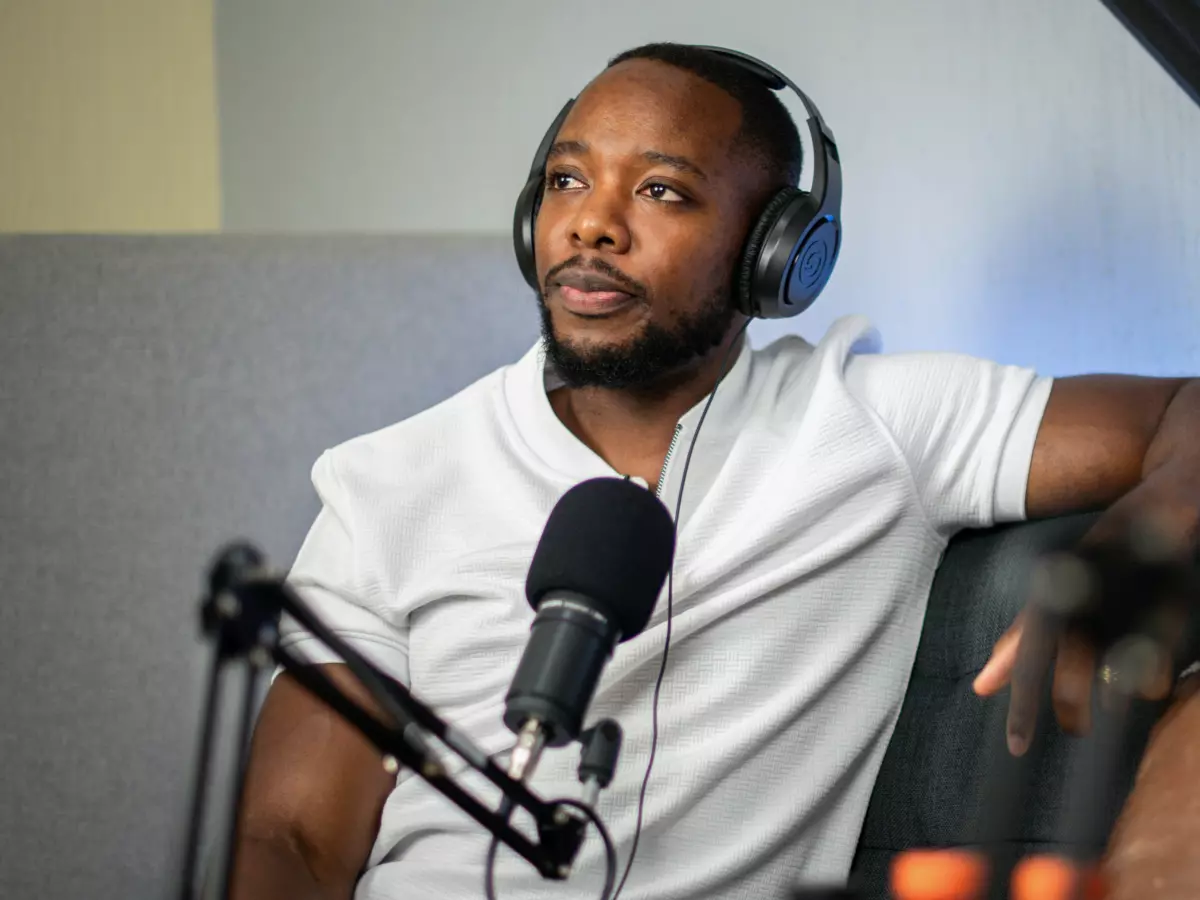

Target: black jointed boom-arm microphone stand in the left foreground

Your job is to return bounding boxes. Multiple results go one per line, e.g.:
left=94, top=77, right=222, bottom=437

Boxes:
left=180, top=545, right=586, bottom=900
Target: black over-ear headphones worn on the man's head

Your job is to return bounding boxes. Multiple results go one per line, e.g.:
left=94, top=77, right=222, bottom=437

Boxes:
left=512, top=46, right=841, bottom=319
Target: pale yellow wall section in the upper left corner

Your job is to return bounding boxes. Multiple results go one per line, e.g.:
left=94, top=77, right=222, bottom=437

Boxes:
left=0, top=0, right=221, bottom=232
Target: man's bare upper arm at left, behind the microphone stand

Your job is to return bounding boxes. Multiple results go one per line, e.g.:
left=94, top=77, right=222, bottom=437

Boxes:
left=226, top=665, right=395, bottom=900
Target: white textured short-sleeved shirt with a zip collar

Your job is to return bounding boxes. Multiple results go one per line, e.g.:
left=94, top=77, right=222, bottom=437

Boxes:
left=278, top=317, right=1051, bottom=900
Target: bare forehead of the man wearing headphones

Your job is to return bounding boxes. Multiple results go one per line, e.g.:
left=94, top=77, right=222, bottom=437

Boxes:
left=558, top=60, right=742, bottom=168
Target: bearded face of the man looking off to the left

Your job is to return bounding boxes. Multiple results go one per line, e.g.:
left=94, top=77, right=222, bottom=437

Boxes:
left=534, top=60, right=766, bottom=388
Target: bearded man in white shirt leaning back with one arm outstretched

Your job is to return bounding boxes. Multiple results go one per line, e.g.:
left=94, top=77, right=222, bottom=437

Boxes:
left=229, top=44, right=1200, bottom=900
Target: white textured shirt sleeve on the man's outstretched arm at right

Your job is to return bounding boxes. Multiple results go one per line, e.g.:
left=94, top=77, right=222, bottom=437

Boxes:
left=846, top=353, right=1054, bottom=535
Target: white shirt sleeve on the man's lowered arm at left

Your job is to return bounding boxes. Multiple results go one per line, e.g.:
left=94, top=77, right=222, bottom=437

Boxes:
left=281, top=451, right=409, bottom=684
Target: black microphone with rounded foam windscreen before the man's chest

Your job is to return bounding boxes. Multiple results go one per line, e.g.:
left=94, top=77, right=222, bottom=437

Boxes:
left=504, top=478, right=676, bottom=781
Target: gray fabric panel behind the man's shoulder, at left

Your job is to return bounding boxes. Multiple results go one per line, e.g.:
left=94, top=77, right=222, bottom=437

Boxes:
left=0, top=235, right=538, bottom=900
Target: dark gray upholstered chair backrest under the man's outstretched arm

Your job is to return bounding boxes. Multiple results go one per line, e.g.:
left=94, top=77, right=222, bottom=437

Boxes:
left=853, top=514, right=1160, bottom=898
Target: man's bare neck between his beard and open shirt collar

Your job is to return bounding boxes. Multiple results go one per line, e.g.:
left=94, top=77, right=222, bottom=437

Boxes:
left=550, top=330, right=744, bottom=487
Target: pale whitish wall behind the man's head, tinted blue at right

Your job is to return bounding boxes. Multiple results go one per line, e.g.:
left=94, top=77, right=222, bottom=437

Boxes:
left=216, top=0, right=1200, bottom=373
